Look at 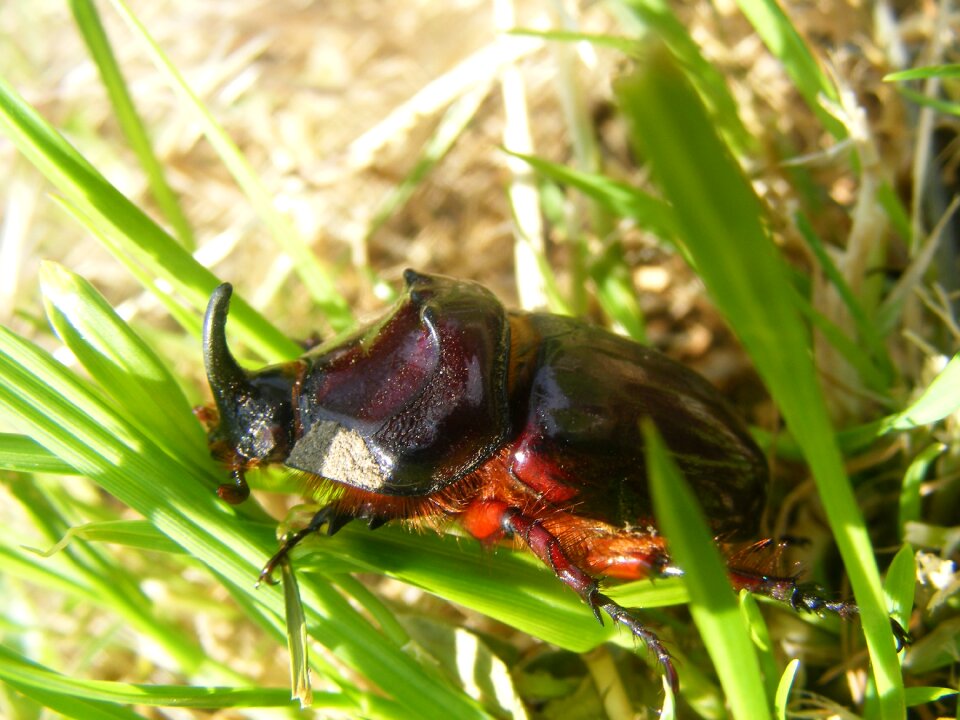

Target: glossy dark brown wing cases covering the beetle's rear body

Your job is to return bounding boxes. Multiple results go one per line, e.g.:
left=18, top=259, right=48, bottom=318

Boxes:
left=511, top=314, right=768, bottom=538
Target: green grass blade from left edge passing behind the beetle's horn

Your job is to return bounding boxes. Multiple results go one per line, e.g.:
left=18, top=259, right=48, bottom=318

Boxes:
left=0, top=77, right=300, bottom=361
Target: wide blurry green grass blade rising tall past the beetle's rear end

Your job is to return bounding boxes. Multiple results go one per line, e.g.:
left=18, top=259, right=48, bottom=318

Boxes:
left=618, top=47, right=905, bottom=719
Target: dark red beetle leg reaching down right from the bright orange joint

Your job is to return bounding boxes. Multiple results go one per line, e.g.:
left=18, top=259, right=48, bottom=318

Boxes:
left=501, top=507, right=680, bottom=694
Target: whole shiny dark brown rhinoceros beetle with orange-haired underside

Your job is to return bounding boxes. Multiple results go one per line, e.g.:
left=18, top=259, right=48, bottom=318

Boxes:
left=203, top=270, right=900, bottom=689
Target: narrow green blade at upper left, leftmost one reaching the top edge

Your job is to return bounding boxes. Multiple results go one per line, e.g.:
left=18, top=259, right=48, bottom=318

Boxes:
left=70, top=0, right=196, bottom=251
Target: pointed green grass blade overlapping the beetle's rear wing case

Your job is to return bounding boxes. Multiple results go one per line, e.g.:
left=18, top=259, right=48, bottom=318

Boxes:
left=643, top=424, right=770, bottom=719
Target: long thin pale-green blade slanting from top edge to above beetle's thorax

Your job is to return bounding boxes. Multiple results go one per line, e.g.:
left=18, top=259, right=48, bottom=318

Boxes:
left=102, top=0, right=353, bottom=330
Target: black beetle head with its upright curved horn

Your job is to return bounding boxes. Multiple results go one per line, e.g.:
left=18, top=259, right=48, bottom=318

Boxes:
left=203, top=283, right=293, bottom=470
